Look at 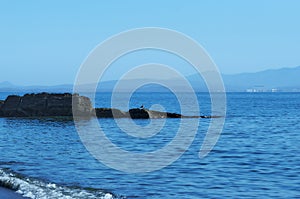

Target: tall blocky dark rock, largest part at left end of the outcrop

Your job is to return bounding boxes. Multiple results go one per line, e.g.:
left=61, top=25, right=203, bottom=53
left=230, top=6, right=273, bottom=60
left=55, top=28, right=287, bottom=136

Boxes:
left=0, top=93, right=92, bottom=117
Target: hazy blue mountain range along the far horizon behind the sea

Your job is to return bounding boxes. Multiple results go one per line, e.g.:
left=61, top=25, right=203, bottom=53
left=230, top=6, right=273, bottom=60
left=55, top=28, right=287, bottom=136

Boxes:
left=0, top=66, right=300, bottom=92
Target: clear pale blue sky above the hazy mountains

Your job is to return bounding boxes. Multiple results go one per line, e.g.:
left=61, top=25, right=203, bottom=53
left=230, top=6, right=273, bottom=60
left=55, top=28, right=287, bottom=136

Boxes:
left=0, top=0, right=300, bottom=85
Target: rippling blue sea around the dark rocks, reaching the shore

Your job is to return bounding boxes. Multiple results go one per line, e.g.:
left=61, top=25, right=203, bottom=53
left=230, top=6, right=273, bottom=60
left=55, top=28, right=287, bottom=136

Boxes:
left=0, top=92, right=300, bottom=199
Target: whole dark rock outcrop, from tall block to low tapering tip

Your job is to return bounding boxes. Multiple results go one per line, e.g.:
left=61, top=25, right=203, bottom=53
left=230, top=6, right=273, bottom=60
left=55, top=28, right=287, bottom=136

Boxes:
left=0, top=93, right=218, bottom=119
